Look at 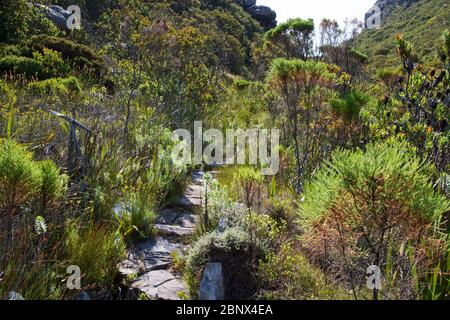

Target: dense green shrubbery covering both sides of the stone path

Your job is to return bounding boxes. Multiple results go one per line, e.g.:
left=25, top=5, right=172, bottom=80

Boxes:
left=0, top=0, right=450, bottom=299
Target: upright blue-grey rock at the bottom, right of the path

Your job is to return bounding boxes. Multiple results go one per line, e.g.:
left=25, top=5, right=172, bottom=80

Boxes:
left=198, top=263, right=225, bottom=300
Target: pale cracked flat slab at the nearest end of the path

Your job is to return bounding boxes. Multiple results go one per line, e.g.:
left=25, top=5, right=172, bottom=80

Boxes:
left=131, top=270, right=187, bottom=300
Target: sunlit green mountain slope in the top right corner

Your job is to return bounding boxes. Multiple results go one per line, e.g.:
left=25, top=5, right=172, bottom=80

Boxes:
left=357, top=0, right=450, bottom=67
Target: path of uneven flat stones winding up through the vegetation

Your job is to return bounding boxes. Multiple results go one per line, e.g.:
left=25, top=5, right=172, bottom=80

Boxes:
left=119, top=171, right=203, bottom=300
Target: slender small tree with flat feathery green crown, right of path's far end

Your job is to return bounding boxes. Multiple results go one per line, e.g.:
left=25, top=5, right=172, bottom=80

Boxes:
left=267, top=58, right=336, bottom=193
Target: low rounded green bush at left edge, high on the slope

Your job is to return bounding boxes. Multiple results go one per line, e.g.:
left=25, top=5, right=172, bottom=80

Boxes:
left=0, top=56, right=45, bottom=79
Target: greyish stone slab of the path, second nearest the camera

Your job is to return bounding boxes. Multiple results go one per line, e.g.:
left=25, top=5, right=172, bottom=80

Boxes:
left=119, top=237, right=186, bottom=275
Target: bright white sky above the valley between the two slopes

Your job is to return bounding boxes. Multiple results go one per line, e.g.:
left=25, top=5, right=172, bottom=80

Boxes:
left=257, top=0, right=376, bottom=25
